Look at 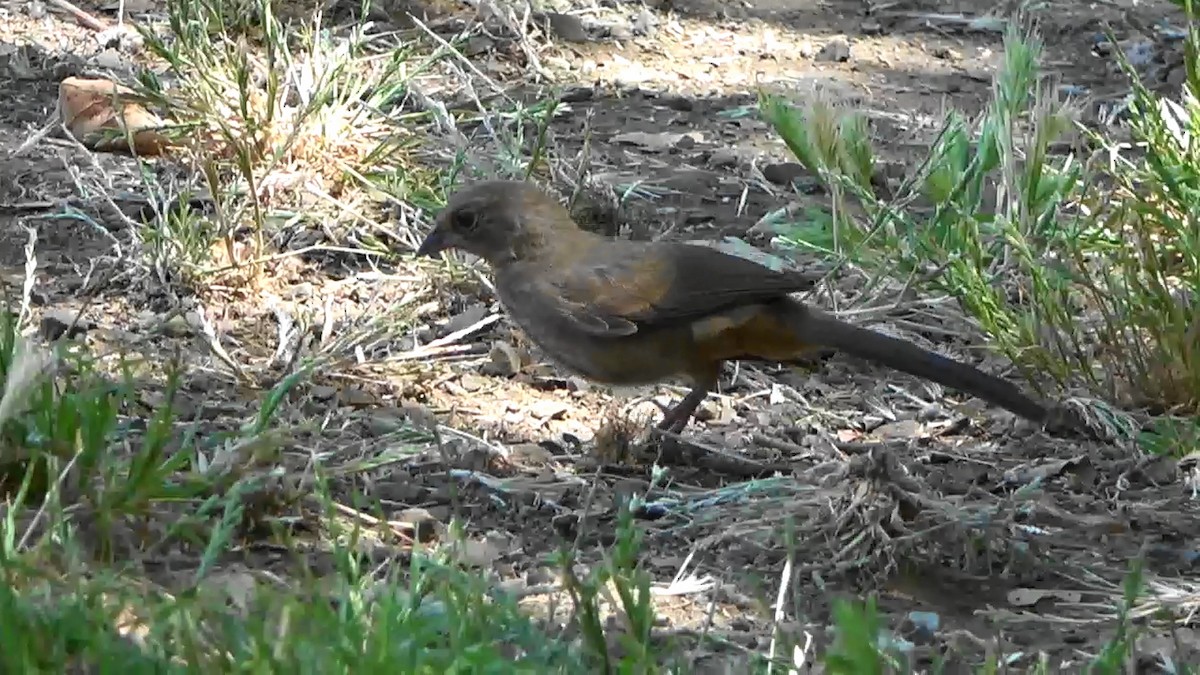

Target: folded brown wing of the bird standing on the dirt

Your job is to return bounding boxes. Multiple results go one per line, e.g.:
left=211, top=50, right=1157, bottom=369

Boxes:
left=539, top=241, right=815, bottom=336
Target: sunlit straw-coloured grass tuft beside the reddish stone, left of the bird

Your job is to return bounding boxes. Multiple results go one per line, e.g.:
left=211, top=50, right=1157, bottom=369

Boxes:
left=129, top=0, right=439, bottom=281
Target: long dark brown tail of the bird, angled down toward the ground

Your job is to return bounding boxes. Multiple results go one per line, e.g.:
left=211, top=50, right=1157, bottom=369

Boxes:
left=791, top=301, right=1048, bottom=423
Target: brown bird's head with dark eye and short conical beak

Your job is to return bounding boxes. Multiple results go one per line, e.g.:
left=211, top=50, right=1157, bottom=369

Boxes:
left=416, top=180, right=580, bottom=267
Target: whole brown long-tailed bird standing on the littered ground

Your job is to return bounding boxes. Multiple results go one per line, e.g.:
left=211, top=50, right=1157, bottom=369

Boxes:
left=418, top=180, right=1048, bottom=434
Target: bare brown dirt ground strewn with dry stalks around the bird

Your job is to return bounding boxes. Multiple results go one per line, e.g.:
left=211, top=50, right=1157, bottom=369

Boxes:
left=0, top=0, right=1200, bottom=673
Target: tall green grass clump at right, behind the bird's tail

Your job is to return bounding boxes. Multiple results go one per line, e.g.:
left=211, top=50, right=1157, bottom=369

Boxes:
left=760, top=13, right=1200, bottom=453
